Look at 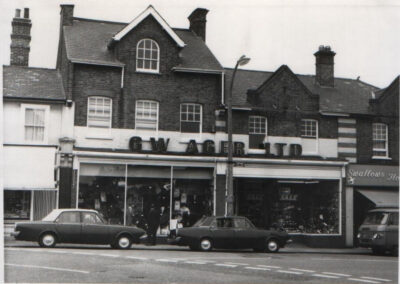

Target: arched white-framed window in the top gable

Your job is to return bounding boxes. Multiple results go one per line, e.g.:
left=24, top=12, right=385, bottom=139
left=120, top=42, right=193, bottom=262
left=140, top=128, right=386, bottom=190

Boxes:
left=136, top=38, right=160, bottom=73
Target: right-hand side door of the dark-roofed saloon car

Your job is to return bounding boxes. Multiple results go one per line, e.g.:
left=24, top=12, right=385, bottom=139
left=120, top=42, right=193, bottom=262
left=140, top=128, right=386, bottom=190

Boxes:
left=233, top=217, right=260, bottom=248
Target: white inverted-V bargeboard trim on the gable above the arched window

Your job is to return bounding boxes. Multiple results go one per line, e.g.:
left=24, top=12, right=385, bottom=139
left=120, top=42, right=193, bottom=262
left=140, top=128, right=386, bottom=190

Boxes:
left=112, top=5, right=185, bottom=47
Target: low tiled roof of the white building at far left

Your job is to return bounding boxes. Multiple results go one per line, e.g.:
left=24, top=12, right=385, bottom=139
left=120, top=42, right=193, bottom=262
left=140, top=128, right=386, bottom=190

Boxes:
left=3, top=66, right=66, bottom=100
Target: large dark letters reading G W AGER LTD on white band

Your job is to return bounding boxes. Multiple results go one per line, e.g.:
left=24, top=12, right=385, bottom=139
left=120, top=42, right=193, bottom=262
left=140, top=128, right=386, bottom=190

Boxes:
left=129, top=136, right=302, bottom=157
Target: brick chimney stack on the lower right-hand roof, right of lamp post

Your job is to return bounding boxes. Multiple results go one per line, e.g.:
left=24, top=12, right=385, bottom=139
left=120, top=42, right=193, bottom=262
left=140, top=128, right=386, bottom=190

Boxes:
left=314, top=45, right=336, bottom=87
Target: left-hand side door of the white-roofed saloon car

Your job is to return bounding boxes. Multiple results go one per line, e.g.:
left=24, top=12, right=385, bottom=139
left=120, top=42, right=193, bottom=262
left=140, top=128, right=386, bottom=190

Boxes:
left=55, top=211, right=82, bottom=243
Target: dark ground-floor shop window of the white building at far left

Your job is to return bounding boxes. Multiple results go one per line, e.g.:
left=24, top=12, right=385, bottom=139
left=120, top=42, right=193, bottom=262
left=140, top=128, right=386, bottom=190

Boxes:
left=4, top=190, right=31, bottom=220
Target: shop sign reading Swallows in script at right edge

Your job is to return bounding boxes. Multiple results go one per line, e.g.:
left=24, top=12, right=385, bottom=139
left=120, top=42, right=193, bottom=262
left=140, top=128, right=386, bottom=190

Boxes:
left=347, top=165, right=399, bottom=186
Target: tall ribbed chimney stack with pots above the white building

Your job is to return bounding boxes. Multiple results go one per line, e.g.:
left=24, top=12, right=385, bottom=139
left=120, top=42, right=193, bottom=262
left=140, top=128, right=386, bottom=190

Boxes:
left=10, top=8, right=32, bottom=66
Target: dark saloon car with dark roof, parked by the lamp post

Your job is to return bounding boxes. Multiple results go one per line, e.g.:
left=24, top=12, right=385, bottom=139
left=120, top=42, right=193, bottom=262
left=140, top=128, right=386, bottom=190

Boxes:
left=175, top=216, right=289, bottom=252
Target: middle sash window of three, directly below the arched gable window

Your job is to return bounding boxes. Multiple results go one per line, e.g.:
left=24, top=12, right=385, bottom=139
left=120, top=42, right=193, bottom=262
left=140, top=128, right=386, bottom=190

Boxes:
left=135, top=100, right=158, bottom=130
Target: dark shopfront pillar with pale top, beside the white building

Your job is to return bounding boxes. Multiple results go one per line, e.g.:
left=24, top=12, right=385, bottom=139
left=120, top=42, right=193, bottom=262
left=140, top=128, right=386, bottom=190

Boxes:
left=58, top=137, right=75, bottom=208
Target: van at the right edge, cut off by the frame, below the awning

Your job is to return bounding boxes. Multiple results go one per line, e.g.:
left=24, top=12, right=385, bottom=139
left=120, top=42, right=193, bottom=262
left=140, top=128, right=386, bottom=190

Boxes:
left=357, top=208, right=399, bottom=255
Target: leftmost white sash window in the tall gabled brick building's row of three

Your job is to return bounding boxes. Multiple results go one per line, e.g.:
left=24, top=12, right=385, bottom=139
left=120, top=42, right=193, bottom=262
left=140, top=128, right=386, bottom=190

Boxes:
left=87, top=97, right=112, bottom=128
